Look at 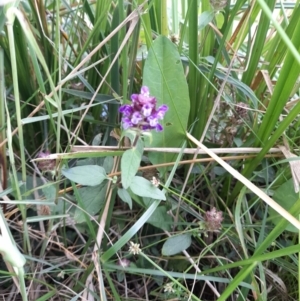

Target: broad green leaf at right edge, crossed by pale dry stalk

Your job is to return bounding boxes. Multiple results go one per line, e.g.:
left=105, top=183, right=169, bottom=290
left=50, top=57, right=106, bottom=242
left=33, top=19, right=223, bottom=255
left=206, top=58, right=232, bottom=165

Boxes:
left=269, top=179, right=300, bottom=233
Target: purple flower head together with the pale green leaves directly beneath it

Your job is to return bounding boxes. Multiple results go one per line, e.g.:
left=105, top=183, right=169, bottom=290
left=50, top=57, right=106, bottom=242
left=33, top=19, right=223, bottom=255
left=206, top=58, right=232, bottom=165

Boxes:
left=119, top=86, right=169, bottom=201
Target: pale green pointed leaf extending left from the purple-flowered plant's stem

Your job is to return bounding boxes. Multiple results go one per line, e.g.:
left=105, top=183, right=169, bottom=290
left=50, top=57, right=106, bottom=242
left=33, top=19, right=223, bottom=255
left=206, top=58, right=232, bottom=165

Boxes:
left=61, top=165, right=107, bottom=186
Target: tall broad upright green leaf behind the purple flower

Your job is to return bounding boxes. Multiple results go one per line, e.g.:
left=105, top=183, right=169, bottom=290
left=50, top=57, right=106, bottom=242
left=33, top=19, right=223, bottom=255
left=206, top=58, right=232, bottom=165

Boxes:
left=143, top=36, right=190, bottom=171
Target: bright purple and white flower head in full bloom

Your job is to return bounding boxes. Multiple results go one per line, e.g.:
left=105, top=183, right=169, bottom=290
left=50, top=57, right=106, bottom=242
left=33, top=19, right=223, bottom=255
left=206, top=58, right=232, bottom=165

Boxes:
left=119, top=86, right=169, bottom=132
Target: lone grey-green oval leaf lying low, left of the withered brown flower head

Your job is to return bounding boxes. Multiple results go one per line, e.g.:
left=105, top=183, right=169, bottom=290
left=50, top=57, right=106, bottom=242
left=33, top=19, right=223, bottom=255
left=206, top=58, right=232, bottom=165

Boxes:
left=161, top=233, right=192, bottom=256
